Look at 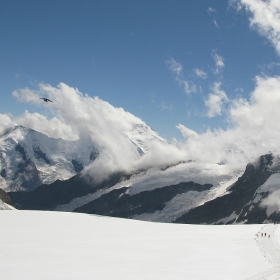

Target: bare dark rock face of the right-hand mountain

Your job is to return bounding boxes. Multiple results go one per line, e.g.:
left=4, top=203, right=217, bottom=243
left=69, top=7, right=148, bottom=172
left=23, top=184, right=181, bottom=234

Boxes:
left=175, top=154, right=273, bottom=224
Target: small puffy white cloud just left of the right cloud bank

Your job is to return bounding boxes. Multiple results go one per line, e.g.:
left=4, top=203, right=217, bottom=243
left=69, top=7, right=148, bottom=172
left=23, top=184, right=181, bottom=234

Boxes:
left=205, top=82, right=228, bottom=118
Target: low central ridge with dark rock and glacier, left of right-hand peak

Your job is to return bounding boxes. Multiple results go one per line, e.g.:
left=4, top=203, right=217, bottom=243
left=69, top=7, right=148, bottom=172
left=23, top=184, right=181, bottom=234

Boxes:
left=10, top=156, right=241, bottom=218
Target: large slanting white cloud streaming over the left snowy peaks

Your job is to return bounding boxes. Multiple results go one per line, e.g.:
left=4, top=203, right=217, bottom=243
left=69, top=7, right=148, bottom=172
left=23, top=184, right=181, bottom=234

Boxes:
left=9, top=83, right=186, bottom=180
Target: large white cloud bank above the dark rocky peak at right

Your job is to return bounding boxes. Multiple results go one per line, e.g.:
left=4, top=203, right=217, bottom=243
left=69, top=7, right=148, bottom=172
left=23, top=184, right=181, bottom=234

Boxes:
left=177, top=77, right=280, bottom=167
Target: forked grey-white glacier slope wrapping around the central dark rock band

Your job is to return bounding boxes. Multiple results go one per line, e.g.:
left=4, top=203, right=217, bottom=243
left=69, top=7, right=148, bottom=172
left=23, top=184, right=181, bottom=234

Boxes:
left=54, top=162, right=243, bottom=222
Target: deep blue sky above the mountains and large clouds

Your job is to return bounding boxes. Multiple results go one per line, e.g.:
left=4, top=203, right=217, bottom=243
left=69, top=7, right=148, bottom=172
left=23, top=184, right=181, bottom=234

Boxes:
left=0, top=0, right=279, bottom=140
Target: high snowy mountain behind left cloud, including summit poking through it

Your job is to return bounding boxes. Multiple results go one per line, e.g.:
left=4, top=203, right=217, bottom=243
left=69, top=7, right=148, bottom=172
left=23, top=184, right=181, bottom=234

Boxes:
left=0, top=123, right=165, bottom=191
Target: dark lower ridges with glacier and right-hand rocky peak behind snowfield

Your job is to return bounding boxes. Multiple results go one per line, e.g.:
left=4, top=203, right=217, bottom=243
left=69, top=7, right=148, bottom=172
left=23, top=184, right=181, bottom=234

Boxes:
left=10, top=154, right=280, bottom=224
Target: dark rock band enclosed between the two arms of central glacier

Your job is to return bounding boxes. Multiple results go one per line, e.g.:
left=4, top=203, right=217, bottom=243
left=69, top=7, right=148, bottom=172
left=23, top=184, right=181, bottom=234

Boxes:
left=74, top=182, right=212, bottom=218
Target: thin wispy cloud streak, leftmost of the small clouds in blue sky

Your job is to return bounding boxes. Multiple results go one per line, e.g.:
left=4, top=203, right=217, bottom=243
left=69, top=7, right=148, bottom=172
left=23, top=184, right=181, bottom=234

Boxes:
left=165, top=57, right=197, bottom=94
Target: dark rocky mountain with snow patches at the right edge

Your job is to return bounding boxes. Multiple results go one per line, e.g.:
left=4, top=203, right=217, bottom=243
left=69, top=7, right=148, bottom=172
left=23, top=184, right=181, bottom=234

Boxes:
left=175, top=154, right=280, bottom=224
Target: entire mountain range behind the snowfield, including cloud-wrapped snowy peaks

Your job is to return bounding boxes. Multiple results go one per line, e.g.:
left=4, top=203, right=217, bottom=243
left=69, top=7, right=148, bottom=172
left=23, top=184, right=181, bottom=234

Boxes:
left=0, top=125, right=280, bottom=224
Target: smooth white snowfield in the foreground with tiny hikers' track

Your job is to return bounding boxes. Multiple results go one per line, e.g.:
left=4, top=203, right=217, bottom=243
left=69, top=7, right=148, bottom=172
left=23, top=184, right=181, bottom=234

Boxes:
left=0, top=210, right=280, bottom=280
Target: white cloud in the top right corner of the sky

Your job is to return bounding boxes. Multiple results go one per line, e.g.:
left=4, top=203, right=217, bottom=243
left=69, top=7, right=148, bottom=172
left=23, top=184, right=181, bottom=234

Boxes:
left=237, top=0, right=280, bottom=55
